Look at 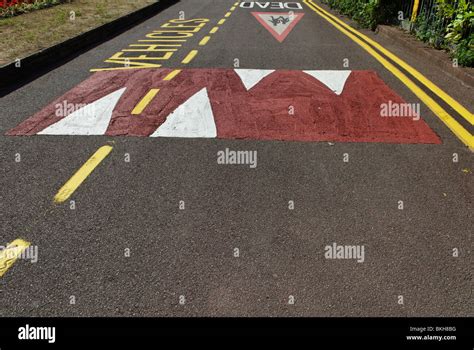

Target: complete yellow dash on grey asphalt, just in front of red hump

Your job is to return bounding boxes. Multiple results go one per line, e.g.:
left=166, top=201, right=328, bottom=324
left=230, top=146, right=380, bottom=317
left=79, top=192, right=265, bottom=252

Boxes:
left=54, top=146, right=113, bottom=203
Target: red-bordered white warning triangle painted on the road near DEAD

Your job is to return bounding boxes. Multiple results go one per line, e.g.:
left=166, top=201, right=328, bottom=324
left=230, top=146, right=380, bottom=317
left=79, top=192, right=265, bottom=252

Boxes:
left=252, top=12, right=304, bottom=42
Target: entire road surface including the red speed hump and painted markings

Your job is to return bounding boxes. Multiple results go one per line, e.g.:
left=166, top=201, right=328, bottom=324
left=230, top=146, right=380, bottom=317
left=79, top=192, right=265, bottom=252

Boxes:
left=0, top=0, right=474, bottom=316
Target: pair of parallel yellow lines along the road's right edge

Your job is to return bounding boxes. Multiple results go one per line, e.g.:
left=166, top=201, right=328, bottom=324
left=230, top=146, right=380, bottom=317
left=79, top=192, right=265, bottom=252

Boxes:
left=303, top=0, right=474, bottom=150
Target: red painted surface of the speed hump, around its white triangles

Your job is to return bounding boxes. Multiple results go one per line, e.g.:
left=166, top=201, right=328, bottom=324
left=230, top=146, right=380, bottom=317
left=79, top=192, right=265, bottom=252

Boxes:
left=8, top=69, right=441, bottom=144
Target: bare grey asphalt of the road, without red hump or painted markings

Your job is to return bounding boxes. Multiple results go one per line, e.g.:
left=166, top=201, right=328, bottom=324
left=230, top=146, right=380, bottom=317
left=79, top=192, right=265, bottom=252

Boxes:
left=0, top=0, right=474, bottom=316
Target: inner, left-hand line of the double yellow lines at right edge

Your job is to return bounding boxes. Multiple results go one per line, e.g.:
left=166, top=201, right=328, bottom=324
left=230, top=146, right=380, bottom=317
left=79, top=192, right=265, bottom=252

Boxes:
left=303, top=0, right=474, bottom=149
